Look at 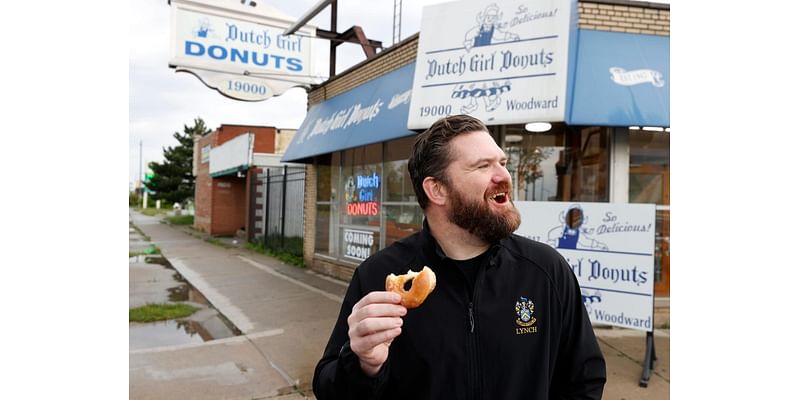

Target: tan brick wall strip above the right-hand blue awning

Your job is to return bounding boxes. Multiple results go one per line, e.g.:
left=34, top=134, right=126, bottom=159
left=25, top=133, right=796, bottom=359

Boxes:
left=578, top=1, right=669, bottom=36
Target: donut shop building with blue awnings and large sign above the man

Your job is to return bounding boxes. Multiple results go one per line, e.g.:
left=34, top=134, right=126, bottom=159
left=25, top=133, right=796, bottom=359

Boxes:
left=282, top=0, right=670, bottom=298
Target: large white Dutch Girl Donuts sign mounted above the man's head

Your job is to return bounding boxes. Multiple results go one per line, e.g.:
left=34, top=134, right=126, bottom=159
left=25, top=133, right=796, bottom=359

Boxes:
left=408, top=0, right=577, bottom=129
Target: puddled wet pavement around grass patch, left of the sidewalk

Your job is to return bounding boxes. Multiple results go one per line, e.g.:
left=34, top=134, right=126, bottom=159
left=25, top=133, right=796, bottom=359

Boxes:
left=129, top=255, right=242, bottom=350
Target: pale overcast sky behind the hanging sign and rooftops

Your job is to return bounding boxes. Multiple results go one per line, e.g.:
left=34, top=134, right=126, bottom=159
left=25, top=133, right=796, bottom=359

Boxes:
left=129, top=0, right=669, bottom=183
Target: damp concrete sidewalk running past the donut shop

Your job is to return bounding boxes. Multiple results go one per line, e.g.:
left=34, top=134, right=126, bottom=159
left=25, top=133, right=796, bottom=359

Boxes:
left=129, top=211, right=669, bottom=399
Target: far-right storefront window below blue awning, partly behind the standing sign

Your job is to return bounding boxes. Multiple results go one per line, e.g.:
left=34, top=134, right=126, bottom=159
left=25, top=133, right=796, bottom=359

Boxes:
left=628, top=129, right=669, bottom=296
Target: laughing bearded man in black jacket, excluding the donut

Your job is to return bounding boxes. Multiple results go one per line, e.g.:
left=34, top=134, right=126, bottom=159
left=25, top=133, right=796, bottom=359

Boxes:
left=314, top=115, right=606, bottom=400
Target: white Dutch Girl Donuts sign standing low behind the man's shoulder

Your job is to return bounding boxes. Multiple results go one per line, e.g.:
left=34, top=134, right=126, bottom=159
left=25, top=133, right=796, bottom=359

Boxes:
left=514, top=201, right=656, bottom=331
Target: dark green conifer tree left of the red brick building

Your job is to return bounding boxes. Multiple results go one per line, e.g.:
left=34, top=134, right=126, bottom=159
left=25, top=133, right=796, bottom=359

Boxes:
left=145, top=118, right=211, bottom=204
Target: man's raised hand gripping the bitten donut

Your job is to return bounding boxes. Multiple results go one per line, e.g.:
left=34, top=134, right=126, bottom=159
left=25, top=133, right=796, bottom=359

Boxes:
left=347, top=292, right=408, bottom=376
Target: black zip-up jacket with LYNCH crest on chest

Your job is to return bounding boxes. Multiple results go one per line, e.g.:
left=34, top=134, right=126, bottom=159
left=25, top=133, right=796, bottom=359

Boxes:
left=313, top=221, right=606, bottom=400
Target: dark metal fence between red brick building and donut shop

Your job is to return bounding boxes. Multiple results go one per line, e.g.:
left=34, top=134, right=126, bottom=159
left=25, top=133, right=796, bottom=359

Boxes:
left=248, top=166, right=306, bottom=257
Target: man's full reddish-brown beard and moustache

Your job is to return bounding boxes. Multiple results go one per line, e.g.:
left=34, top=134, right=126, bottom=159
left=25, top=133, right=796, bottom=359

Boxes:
left=447, top=182, right=521, bottom=244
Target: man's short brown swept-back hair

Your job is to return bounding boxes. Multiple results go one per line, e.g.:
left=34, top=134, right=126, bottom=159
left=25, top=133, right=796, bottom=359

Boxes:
left=408, top=115, right=489, bottom=210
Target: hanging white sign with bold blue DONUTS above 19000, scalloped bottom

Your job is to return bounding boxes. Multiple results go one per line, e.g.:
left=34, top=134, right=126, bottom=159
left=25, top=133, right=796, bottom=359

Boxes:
left=169, top=0, right=321, bottom=101
